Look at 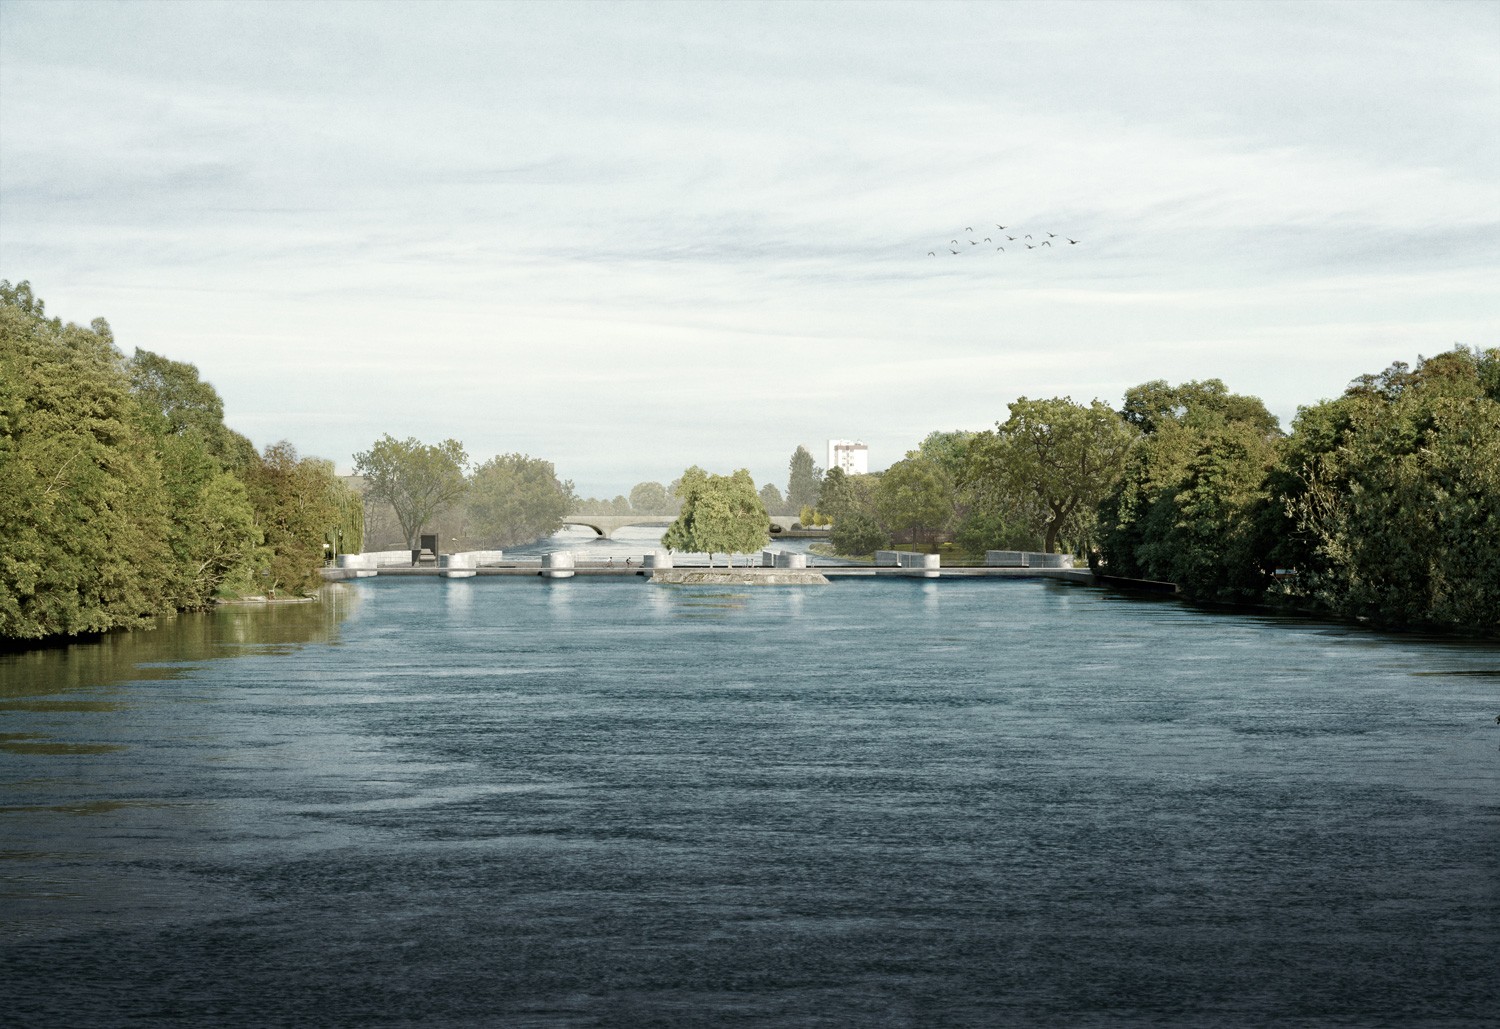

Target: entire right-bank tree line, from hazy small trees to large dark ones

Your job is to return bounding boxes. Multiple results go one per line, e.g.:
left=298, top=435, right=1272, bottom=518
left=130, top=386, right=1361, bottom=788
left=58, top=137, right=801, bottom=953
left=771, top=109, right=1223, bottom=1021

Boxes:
left=815, top=347, right=1500, bottom=636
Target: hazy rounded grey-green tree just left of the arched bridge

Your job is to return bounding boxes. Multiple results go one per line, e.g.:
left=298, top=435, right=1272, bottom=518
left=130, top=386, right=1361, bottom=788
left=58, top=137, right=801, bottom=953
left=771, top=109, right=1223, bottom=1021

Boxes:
left=467, top=455, right=573, bottom=548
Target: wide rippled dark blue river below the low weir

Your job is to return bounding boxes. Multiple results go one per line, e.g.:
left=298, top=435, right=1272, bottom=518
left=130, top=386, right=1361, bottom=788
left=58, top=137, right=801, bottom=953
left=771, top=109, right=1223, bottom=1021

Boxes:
left=0, top=579, right=1500, bottom=1026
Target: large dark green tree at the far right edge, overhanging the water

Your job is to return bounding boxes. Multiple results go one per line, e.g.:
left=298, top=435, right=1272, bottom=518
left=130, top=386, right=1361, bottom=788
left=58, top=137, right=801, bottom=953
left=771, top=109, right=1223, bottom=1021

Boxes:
left=1269, top=348, right=1500, bottom=636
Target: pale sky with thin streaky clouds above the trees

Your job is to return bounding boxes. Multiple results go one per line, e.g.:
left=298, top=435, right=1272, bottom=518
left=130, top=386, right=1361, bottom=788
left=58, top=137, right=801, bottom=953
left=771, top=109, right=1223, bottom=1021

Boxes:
left=0, top=0, right=1500, bottom=497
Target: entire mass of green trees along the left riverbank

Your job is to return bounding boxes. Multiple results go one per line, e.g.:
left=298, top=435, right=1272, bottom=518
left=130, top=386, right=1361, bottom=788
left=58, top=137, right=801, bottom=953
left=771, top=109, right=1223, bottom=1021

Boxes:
left=0, top=281, right=363, bottom=639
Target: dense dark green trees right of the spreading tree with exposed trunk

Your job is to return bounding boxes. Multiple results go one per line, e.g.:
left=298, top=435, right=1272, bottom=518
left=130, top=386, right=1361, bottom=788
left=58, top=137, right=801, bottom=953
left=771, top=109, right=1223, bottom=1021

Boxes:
left=1100, top=357, right=1500, bottom=636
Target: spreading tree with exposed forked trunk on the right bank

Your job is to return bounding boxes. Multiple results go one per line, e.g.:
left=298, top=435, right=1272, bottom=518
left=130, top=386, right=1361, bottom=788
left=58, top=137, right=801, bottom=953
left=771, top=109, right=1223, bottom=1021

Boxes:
left=974, top=396, right=1137, bottom=554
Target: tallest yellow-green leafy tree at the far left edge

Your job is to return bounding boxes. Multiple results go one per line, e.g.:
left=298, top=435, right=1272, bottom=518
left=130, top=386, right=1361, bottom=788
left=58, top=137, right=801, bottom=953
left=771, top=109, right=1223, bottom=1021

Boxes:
left=0, top=282, right=173, bottom=639
